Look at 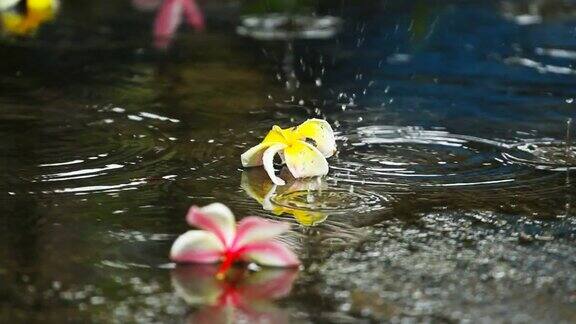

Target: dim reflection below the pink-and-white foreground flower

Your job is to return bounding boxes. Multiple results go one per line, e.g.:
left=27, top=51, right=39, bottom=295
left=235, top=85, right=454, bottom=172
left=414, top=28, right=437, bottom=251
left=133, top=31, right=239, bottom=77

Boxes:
left=172, top=265, right=298, bottom=323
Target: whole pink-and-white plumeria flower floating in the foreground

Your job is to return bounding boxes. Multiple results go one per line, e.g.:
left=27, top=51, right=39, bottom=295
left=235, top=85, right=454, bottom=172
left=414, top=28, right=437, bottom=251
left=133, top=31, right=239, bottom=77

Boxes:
left=170, top=203, right=300, bottom=275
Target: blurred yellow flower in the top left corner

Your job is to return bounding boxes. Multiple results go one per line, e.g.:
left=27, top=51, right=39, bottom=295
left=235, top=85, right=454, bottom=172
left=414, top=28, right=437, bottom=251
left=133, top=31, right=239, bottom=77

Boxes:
left=0, top=0, right=59, bottom=36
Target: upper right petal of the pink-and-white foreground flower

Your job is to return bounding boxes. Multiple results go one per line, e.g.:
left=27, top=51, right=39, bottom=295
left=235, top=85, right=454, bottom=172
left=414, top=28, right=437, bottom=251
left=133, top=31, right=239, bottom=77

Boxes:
left=232, top=217, right=290, bottom=250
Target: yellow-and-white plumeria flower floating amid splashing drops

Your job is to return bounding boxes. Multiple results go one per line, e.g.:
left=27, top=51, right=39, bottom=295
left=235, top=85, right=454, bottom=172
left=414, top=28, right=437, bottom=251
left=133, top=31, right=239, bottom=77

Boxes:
left=241, top=119, right=336, bottom=186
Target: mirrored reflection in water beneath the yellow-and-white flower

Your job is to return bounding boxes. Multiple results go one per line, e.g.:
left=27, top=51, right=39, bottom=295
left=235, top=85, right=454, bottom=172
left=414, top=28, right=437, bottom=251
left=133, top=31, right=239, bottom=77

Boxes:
left=241, top=168, right=328, bottom=226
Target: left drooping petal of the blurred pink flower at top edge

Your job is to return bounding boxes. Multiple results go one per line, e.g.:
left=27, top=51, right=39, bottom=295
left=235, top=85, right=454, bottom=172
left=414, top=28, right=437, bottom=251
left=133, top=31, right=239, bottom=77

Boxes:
left=154, top=0, right=184, bottom=48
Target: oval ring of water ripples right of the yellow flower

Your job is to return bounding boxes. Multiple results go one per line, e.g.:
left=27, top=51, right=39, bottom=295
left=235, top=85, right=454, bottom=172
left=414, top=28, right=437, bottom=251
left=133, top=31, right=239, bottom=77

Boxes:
left=331, top=126, right=565, bottom=197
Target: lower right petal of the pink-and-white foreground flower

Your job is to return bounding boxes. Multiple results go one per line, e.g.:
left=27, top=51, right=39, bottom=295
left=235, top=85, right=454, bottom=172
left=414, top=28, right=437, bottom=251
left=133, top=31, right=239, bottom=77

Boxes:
left=242, top=241, right=300, bottom=267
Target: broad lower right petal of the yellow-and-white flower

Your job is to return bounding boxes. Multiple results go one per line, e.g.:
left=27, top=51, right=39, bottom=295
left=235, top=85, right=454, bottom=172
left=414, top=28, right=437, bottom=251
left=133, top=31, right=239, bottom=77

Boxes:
left=284, top=141, right=328, bottom=178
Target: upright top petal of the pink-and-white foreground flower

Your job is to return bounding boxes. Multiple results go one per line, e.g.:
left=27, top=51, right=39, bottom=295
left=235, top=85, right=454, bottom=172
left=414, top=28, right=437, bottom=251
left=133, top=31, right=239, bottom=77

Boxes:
left=186, top=203, right=236, bottom=247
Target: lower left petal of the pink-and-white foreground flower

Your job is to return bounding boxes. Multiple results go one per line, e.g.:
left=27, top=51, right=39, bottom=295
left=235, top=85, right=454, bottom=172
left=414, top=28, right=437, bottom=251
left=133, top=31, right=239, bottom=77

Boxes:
left=170, top=230, right=224, bottom=263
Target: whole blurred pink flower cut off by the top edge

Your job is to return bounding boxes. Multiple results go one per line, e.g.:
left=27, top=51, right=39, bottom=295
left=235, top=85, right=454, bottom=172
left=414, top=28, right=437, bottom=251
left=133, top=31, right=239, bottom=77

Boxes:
left=132, top=0, right=205, bottom=49
